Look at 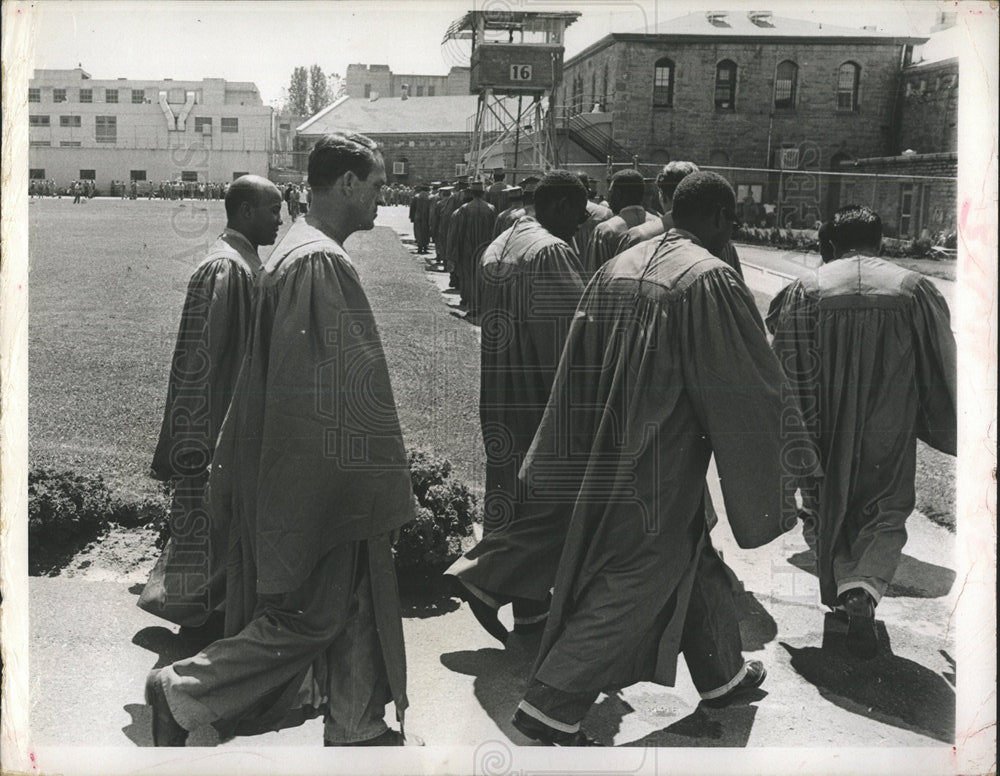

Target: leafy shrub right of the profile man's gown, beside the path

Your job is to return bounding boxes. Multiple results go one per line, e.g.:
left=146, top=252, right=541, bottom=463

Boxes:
left=393, top=450, right=481, bottom=572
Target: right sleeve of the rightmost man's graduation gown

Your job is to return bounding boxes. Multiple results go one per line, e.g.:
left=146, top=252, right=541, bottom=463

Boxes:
left=913, top=278, right=958, bottom=455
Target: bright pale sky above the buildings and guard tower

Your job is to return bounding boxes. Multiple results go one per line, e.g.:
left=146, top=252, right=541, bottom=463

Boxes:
left=30, top=0, right=953, bottom=104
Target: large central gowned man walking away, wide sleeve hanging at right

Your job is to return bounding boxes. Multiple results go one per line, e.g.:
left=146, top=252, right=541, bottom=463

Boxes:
left=514, top=172, right=815, bottom=746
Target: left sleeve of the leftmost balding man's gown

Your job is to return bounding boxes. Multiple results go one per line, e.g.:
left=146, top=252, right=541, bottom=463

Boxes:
left=152, top=259, right=253, bottom=480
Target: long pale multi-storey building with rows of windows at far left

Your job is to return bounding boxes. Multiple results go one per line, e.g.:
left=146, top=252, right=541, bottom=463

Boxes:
left=28, top=67, right=273, bottom=191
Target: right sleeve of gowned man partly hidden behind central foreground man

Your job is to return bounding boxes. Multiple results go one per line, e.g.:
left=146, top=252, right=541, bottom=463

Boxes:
left=528, top=244, right=583, bottom=369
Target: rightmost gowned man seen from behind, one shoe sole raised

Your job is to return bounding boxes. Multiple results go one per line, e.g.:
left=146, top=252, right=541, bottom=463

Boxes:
left=767, top=205, right=956, bottom=658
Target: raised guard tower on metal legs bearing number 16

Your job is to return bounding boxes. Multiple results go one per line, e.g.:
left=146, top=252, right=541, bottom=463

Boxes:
left=442, top=10, right=580, bottom=178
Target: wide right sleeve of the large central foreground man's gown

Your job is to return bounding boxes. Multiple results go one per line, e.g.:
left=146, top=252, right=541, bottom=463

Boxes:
left=680, top=269, right=818, bottom=548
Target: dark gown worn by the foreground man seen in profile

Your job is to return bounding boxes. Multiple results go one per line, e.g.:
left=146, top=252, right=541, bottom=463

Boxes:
left=210, top=216, right=414, bottom=708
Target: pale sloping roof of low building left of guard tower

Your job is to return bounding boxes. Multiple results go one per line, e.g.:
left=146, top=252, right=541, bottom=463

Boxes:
left=296, top=94, right=500, bottom=135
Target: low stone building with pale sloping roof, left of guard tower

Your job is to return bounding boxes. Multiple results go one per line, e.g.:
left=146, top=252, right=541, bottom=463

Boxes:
left=298, top=94, right=488, bottom=186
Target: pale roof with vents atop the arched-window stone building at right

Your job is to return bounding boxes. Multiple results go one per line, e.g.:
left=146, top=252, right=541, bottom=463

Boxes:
left=566, top=10, right=927, bottom=64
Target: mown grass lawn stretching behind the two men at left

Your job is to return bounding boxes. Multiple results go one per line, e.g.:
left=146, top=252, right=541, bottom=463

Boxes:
left=29, top=198, right=955, bottom=528
